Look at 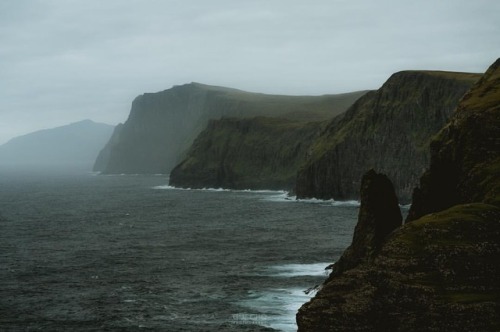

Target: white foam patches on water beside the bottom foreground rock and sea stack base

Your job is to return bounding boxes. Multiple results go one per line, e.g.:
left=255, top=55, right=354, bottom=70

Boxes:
left=237, top=262, right=331, bottom=332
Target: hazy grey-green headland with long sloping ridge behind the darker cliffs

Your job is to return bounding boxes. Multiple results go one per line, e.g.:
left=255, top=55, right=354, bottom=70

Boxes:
left=95, top=83, right=364, bottom=173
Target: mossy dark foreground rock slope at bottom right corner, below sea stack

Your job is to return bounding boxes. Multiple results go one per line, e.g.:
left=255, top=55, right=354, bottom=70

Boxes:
left=297, top=204, right=500, bottom=332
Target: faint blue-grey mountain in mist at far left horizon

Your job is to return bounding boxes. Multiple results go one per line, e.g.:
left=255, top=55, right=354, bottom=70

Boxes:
left=0, top=120, right=113, bottom=170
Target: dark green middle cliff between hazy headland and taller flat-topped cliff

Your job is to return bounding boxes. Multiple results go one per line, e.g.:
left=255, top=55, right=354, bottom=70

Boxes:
left=170, top=117, right=322, bottom=190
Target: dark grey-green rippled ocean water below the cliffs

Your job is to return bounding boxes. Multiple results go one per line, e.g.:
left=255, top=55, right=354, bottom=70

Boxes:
left=0, top=170, right=358, bottom=331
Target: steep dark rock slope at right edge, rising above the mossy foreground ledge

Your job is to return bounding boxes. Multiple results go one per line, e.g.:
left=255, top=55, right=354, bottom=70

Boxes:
left=408, top=60, right=500, bottom=220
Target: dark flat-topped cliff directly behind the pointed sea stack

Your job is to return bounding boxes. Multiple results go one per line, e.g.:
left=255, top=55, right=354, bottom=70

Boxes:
left=296, top=71, right=480, bottom=202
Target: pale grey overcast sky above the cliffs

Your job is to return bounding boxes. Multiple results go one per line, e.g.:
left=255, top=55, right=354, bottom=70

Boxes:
left=0, top=0, right=500, bottom=144
